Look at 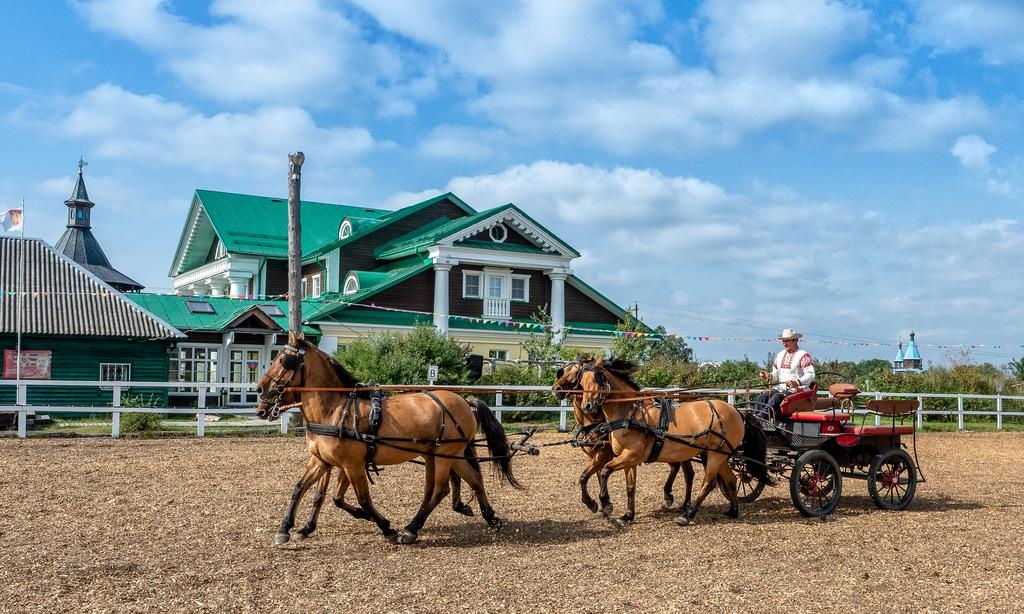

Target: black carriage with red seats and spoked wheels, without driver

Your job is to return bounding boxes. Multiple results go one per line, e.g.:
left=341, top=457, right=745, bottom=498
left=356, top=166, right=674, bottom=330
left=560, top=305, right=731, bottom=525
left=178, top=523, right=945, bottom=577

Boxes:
left=730, top=384, right=925, bottom=517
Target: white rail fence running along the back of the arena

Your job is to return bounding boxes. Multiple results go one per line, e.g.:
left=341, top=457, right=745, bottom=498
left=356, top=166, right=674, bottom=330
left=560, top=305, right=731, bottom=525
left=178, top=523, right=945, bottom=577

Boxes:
left=0, top=380, right=1024, bottom=438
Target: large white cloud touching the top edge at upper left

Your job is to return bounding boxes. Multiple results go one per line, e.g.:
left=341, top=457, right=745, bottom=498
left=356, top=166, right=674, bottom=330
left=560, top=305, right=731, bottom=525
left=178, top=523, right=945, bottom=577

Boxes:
left=75, top=0, right=432, bottom=108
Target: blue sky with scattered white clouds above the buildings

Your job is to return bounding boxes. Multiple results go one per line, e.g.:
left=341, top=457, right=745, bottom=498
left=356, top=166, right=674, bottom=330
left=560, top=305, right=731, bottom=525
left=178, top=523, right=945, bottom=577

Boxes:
left=0, top=0, right=1024, bottom=365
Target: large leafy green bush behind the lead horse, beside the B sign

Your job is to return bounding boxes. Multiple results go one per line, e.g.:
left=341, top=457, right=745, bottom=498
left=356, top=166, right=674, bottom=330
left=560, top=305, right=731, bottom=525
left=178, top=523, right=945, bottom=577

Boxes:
left=335, top=324, right=469, bottom=384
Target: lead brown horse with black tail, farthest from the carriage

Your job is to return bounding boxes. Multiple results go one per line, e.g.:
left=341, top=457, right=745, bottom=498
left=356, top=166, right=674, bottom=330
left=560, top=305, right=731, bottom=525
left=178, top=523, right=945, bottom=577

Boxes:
left=256, top=336, right=521, bottom=544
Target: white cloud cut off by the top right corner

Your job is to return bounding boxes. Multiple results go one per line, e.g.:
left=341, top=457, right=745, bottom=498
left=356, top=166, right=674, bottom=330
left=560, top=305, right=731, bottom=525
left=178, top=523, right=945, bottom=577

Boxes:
left=910, top=0, right=1024, bottom=64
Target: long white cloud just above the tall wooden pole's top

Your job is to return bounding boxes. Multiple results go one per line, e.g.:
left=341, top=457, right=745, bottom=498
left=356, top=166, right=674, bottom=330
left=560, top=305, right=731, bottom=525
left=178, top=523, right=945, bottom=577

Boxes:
left=59, top=84, right=386, bottom=176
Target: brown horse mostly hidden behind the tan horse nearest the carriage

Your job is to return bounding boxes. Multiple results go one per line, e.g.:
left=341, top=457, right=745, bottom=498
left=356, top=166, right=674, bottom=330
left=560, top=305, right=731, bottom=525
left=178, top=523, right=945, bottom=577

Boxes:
left=551, top=354, right=693, bottom=522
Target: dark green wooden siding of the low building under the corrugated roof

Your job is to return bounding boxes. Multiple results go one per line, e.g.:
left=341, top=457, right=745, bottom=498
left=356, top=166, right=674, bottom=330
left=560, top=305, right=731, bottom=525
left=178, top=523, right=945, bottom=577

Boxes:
left=0, top=336, right=170, bottom=411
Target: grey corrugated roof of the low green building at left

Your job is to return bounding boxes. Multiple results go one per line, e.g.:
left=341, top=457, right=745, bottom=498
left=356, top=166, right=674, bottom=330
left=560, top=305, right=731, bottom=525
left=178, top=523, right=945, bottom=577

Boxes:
left=0, top=236, right=184, bottom=339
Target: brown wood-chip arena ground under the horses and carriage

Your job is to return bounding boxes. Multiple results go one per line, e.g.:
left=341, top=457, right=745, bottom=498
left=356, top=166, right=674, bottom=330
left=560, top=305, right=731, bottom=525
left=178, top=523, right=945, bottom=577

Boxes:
left=0, top=434, right=1024, bottom=613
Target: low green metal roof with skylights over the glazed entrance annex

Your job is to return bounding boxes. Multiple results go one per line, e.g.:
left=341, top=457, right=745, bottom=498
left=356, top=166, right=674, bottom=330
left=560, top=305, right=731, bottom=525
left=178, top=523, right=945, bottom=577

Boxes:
left=123, top=293, right=323, bottom=335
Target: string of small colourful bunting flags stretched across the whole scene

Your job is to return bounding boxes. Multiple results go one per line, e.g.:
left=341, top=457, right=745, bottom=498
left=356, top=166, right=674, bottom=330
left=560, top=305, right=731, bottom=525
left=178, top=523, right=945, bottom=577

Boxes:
left=0, top=291, right=1024, bottom=350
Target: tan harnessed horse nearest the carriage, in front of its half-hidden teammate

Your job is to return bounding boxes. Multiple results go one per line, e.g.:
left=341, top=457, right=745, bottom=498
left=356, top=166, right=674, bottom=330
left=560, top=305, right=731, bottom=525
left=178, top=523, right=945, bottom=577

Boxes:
left=580, top=358, right=744, bottom=525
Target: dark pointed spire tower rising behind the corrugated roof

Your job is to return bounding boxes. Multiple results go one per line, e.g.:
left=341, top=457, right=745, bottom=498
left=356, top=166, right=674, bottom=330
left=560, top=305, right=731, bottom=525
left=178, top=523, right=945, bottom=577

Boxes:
left=54, top=159, right=142, bottom=292
